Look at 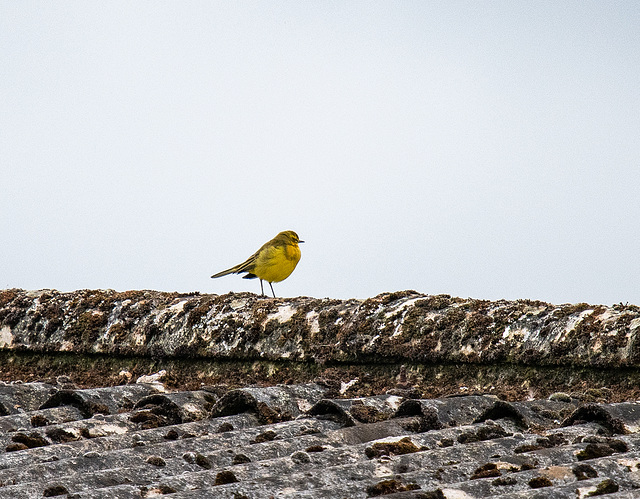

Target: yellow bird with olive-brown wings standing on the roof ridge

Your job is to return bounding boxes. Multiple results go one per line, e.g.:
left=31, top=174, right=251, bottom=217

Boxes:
left=211, top=230, right=304, bottom=298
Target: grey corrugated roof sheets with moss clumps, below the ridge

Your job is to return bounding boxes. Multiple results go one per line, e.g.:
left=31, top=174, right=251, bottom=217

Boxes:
left=0, top=377, right=640, bottom=499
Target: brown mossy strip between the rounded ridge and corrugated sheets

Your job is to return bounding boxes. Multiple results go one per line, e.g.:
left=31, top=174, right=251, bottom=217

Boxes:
left=0, top=350, right=640, bottom=406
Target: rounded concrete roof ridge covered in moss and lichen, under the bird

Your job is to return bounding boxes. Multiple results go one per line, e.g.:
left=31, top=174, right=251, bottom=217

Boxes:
left=0, top=289, right=640, bottom=368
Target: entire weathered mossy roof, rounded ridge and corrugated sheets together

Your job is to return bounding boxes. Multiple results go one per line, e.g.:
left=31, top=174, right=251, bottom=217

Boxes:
left=0, top=289, right=640, bottom=499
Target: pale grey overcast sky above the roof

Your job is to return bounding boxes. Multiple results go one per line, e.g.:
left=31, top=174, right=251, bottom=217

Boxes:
left=0, top=0, right=640, bottom=304
